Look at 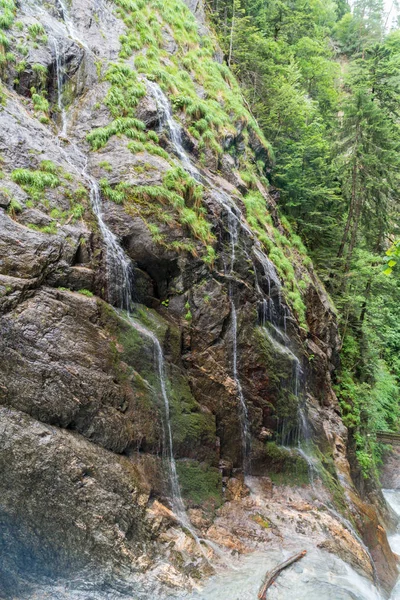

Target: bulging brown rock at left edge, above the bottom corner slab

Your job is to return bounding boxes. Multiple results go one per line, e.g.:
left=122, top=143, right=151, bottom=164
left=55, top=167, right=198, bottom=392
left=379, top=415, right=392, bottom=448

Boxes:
left=0, top=290, right=150, bottom=452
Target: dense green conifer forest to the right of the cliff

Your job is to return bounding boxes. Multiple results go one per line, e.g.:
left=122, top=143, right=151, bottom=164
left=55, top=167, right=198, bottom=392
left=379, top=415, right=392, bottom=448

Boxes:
left=208, top=0, right=400, bottom=478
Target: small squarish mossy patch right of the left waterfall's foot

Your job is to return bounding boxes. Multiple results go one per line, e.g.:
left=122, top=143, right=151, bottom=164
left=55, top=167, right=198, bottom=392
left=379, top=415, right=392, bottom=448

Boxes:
left=176, top=460, right=222, bottom=508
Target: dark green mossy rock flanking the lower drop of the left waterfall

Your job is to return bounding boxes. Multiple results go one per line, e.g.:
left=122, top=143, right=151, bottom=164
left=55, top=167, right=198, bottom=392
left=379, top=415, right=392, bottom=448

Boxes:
left=100, top=303, right=216, bottom=463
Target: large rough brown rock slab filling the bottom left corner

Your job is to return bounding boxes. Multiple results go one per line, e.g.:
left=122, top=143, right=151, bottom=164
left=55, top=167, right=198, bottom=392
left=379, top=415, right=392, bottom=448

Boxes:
left=0, top=408, right=151, bottom=593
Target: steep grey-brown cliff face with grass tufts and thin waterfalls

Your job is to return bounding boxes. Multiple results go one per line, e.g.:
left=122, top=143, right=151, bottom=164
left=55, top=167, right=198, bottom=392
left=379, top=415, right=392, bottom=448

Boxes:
left=0, top=0, right=396, bottom=598
